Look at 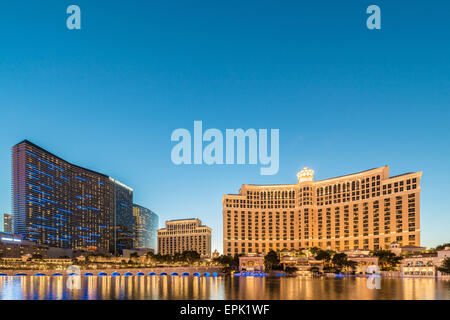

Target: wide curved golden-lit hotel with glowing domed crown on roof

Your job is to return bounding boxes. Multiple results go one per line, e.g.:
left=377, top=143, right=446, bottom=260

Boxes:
left=222, top=166, right=422, bottom=255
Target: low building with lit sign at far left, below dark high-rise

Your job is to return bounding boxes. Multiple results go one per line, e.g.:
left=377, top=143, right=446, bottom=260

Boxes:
left=0, top=232, right=48, bottom=258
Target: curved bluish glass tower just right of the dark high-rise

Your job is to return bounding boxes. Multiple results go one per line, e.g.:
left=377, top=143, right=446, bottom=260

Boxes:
left=133, top=204, right=159, bottom=250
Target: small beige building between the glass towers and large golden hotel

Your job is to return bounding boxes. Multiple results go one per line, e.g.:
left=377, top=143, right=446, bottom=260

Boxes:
left=158, top=219, right=211, bottom=258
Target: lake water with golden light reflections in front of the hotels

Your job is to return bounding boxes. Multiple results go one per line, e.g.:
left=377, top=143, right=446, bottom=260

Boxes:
left=0, top=276, right=450, bottom=300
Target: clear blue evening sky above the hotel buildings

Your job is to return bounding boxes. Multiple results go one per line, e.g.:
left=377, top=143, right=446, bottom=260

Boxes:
left=0, top=0, right=450, bottom=250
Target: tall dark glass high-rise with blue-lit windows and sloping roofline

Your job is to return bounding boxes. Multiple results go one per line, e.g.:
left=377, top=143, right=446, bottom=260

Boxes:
left=12, top=140, right=134, bottom=252
